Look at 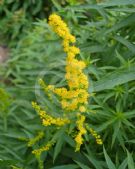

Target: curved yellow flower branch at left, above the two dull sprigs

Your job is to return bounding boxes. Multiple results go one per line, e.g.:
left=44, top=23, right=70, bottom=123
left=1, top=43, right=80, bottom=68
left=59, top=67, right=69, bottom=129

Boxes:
left=32, top=102, right=70, bottom=126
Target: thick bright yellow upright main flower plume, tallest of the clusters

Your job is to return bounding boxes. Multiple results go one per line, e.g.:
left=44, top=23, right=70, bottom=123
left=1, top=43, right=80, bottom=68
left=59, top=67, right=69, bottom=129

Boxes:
left=49, top=14, right=89, bottom=112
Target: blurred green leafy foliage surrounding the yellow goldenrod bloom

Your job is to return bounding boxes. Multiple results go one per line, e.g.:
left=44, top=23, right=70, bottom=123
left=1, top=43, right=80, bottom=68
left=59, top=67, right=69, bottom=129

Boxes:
left=0, top=0, right=135, bottom=169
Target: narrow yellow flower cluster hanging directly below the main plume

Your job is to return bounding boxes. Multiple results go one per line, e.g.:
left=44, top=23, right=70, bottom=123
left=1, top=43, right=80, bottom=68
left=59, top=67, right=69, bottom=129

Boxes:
left=75, top=114, right=86, bottom=151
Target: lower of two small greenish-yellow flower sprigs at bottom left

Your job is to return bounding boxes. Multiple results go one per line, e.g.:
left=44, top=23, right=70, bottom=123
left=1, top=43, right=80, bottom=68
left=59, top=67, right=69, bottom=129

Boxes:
left=32, top=141, right=55, bottom=156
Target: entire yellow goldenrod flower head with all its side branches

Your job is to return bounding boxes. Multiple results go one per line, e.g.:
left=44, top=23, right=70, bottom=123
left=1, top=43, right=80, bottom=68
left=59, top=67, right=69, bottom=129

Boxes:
left=28, top=14, right=102, bottom=168
